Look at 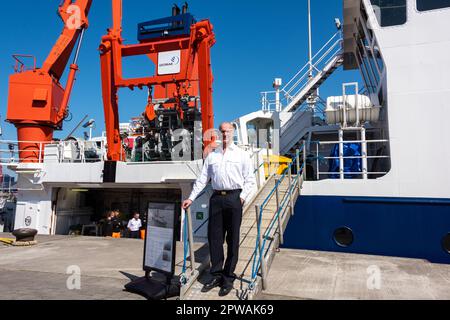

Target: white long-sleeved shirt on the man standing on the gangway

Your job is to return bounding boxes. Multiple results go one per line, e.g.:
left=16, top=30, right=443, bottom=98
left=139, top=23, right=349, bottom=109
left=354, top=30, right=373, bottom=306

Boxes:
left=189, top=144, right=256, bottom=201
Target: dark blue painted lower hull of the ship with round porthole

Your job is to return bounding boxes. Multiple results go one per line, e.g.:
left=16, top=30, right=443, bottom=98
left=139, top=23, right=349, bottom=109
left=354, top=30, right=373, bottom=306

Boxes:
left=284, top=196, right=450, bottom=264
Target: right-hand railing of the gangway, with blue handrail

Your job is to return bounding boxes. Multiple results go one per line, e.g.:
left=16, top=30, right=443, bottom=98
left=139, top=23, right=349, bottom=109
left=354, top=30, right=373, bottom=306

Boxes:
left=244, top=143, right=305, bottom=291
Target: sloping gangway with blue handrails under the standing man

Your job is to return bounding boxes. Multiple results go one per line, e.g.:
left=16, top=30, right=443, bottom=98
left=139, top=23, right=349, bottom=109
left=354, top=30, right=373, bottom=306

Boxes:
left=180, top=145, right=304, bottom=300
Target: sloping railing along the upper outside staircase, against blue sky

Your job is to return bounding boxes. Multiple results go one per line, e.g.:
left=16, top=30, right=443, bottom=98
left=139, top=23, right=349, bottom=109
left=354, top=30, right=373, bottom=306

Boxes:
left=261, top=30, right=343, bottom=112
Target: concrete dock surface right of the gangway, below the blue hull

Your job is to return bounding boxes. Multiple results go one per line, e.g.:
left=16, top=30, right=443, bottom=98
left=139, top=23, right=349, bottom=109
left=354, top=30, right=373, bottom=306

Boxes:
left=259, top=249, right=450, bottom=300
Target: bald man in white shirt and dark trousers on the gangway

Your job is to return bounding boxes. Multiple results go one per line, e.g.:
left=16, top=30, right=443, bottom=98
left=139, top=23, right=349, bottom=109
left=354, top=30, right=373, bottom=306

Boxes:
left=183, top=123, right=256, bottom=296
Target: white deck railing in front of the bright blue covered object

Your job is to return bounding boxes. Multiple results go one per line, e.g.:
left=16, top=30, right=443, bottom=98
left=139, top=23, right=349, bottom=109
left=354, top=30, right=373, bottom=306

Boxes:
left=305, top=139, right=391, bottom=181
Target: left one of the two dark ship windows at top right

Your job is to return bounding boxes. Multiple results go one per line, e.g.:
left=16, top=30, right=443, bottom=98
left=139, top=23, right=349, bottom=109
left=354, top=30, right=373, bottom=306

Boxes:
left=370, top=0, right=406, bottom=27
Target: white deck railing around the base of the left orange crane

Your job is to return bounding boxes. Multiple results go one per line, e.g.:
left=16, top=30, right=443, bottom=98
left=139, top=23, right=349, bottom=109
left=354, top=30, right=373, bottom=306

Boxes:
left=0, top=140, right=106, bottom=166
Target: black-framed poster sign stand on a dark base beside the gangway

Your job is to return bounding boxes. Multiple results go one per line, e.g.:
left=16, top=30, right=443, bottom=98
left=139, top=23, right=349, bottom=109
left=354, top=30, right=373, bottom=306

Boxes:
left=125, top=202, right=180, bottom=300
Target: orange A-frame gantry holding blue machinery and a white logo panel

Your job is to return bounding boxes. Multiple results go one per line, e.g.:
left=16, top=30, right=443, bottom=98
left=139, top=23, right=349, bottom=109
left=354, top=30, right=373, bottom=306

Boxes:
left=100, top=0, right=215, bottom=161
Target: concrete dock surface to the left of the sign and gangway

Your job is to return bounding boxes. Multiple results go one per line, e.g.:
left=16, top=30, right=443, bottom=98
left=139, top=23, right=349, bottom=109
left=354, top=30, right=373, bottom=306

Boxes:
left=0, top=233, right=209, bottom=300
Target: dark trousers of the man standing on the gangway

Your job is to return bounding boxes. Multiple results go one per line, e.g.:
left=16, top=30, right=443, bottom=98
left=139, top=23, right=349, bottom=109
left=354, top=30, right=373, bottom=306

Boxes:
left=208, top=190, right=242, bottom=286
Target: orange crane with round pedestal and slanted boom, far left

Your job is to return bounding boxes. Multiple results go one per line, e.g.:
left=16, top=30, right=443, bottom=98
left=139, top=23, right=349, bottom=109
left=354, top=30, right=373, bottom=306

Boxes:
left=7, top=0, right=92, bottom=162
